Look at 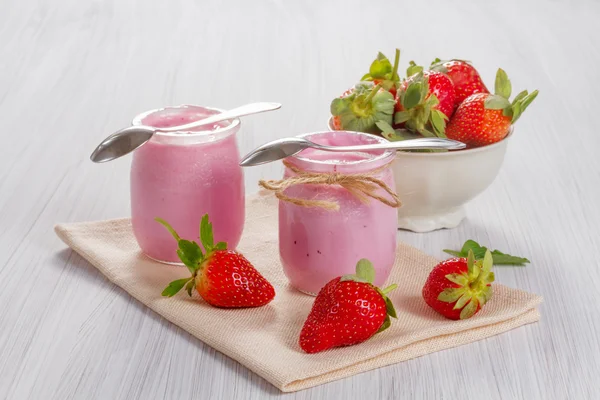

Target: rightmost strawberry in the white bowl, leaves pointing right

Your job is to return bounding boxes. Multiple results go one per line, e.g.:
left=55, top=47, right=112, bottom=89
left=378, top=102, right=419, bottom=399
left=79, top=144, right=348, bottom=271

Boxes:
left=446, top=69, right=538, bottom=148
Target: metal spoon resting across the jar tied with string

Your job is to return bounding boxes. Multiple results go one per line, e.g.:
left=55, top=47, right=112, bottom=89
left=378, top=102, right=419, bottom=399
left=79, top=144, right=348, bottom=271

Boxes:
left=240, top=137, right=466, bottom=167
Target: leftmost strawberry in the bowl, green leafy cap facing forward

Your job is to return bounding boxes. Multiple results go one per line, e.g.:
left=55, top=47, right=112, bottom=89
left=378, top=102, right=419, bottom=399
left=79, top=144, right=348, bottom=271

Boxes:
left=330, top=81, right=394, bottom=133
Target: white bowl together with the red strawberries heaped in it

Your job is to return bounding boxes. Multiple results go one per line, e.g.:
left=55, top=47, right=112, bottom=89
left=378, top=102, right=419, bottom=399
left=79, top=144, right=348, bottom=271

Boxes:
left=328, top=49, right=538, bottom=232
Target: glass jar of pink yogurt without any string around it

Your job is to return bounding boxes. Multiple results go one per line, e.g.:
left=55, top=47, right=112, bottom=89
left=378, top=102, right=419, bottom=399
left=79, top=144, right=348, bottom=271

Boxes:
left=131, top=105, right=244, bottom=263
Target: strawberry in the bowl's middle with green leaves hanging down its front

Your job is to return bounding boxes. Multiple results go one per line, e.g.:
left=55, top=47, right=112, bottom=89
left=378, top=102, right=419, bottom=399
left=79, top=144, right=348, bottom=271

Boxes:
left=394, top=65, right=454, bottom=137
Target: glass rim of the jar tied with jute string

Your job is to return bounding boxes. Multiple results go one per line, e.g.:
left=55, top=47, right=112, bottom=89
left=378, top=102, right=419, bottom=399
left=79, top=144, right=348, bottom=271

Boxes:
left=290, top=130, right=396, bottom=170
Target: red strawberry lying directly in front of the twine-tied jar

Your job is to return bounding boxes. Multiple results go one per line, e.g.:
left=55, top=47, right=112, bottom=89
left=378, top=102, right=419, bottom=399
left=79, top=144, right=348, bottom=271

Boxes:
left=299, top=259, right=396, bottom=353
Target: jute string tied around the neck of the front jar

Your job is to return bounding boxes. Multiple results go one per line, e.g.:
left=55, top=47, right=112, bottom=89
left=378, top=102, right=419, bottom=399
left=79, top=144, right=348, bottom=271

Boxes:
left=258, top=161, right=402, bottom=211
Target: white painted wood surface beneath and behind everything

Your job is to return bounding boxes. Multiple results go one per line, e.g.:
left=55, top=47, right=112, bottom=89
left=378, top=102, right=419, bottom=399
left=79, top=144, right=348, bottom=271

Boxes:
left=0, top=0, right=600, bottom=400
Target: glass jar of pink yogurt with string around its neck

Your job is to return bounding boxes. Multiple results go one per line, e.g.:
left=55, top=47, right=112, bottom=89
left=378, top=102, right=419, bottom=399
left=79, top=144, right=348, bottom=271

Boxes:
left=279, top=131, right=398, bottom=295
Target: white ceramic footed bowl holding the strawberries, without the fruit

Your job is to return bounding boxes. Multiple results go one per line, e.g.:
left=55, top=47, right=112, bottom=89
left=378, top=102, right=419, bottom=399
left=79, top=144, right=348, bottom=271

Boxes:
left=328, top=116, right=512, bottom=232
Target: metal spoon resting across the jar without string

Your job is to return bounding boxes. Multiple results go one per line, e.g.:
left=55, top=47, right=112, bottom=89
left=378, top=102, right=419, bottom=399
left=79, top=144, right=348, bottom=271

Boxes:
left=90, top=103, right=281, bottom=163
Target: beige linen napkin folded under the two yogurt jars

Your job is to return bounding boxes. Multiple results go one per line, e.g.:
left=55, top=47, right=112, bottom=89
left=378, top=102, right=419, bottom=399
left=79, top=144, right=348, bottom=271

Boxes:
left=55, top=195, right=542, bottom=392
